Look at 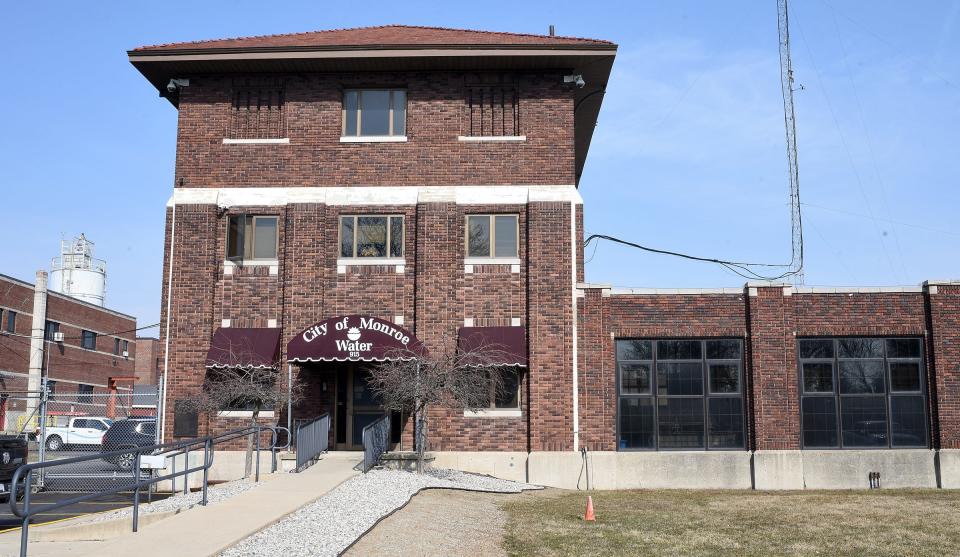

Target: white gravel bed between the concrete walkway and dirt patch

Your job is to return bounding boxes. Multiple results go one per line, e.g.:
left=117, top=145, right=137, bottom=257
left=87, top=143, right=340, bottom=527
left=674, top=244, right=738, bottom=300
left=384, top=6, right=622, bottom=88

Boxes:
left=221, top=469, right=541, bottom=557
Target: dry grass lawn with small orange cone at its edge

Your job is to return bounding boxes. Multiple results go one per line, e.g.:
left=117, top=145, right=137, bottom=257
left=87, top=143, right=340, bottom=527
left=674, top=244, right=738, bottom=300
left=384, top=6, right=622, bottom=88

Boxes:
left=503, top=490, right=960, bottom=557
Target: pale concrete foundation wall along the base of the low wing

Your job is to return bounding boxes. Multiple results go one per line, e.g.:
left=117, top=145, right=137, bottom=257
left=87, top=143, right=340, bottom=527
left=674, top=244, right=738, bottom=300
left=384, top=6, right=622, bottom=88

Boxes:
left=433, top=449, right=944, bottom=490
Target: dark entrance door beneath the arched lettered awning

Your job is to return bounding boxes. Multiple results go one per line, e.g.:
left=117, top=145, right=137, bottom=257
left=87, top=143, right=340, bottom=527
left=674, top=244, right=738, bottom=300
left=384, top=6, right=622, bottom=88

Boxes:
left=336, top=363, right=384, bottom=450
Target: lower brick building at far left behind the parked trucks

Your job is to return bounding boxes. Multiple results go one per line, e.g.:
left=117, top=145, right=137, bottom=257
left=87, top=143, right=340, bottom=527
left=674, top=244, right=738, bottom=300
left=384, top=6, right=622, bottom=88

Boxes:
left=0, top=272, right=137, bottom=432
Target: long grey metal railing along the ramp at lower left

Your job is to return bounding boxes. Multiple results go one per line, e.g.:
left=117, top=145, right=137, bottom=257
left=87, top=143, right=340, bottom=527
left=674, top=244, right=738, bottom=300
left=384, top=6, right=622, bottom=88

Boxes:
left=9, top=426, right=277, bottom=557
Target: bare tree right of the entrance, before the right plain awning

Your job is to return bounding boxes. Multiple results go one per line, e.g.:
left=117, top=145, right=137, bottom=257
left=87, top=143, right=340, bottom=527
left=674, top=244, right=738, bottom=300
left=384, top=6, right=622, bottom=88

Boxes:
left=367, top=337, right=510, bottom=472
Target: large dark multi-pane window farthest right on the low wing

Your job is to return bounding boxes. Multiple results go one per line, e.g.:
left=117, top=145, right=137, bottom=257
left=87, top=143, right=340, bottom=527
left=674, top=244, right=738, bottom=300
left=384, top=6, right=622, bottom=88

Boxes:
left=797, top=338, right=927, bottom=449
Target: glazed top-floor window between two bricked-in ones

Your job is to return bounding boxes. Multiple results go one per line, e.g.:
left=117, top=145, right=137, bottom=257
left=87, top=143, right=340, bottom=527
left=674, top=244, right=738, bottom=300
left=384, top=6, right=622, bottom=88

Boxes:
left=343, top=89, right=407, bottom=137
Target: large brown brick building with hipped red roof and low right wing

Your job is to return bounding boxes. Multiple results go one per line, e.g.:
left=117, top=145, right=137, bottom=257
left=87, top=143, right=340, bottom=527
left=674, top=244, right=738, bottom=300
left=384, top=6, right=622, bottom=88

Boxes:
left=128, top=26, right=960, bottom=487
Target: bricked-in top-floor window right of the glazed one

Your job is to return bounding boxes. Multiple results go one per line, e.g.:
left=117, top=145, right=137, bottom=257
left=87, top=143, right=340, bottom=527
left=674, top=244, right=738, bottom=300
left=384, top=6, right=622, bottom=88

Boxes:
left=464, top=76, right=520, bottom=137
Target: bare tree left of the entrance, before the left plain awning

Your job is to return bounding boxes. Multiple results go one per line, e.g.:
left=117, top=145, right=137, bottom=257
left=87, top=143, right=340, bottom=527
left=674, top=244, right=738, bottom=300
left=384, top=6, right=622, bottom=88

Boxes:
left=183, top=345, right=304, bottom=476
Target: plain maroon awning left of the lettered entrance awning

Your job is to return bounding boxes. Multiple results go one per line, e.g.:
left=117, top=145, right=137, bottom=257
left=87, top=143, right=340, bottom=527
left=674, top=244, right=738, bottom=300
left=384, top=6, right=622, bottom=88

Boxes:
left=207, top=327, right=280, bottom=368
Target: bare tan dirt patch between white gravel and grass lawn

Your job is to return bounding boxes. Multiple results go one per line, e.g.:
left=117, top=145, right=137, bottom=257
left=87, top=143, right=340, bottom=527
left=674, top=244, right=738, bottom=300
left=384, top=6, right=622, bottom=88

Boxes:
left=344, top=489, right=531, bottom=557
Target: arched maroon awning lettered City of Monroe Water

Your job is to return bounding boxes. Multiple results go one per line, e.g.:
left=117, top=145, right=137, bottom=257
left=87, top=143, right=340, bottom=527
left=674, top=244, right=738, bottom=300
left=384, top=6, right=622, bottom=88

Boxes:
left=287, top=315, right=423, bottom=362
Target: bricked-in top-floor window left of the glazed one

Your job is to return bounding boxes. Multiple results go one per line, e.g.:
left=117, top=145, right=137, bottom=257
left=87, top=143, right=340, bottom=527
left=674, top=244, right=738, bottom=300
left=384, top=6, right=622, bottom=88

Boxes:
left=227, top=78, right=287, bottom=139
